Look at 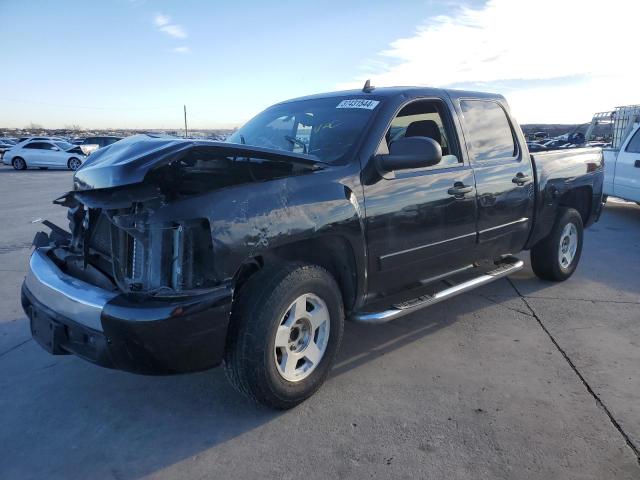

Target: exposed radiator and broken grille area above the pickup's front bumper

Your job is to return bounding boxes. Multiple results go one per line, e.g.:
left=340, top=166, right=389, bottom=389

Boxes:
left=48, top=193, right=216, bottom=296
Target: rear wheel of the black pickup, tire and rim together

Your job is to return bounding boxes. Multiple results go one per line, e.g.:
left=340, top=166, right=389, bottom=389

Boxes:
left=531, top=208, right=583, bottom=282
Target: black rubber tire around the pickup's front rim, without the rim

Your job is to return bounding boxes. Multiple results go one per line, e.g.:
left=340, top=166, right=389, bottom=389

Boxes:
left=224, top=263, right=344, bottom=409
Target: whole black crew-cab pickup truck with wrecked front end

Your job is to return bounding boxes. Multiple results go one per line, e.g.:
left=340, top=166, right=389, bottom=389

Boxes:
left=22, top=85, right=603, bottom=408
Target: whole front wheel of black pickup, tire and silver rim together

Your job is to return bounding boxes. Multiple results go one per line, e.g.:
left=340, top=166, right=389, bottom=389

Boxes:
left=225, top=263, right=344, bottom=409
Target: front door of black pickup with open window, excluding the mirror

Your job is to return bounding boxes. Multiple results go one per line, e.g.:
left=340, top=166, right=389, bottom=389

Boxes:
left=364, top=99, right=476, bottom=297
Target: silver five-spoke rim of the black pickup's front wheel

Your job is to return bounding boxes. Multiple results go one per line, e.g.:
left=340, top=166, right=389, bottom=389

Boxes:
left=273, top=293, right=331, bottom=382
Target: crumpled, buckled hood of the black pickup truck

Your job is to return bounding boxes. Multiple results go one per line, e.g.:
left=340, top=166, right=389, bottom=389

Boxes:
left=73, top=135, right=323, bottom=191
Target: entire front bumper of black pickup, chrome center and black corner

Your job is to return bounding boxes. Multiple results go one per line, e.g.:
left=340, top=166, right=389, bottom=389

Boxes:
left=22, top=247, right=238, bottom=375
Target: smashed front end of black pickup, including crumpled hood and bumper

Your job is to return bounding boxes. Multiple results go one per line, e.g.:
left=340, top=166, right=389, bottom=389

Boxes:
left=22, top=136, right=322, bottom=374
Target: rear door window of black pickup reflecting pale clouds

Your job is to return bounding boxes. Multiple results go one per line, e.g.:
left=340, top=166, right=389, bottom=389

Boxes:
left=460, top=100, right=517, bottom=162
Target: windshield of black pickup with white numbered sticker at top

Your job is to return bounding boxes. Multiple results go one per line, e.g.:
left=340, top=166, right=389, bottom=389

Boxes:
left=227, top=97, right=380, bottom=163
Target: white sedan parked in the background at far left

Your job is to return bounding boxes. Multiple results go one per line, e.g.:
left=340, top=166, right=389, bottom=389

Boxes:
left=2, top=140, right=86, bottom=170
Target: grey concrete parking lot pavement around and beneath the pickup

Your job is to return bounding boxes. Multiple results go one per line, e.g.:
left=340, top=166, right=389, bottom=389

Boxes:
left=0, top=168, right=640, bottom=480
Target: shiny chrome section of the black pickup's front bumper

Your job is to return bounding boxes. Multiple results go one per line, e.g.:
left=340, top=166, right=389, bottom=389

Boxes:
left=24, top=247, right=118, bottom=332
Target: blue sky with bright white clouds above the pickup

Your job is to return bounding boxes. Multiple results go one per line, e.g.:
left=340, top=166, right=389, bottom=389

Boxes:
left=0, top=0, right=640, bottom=129
